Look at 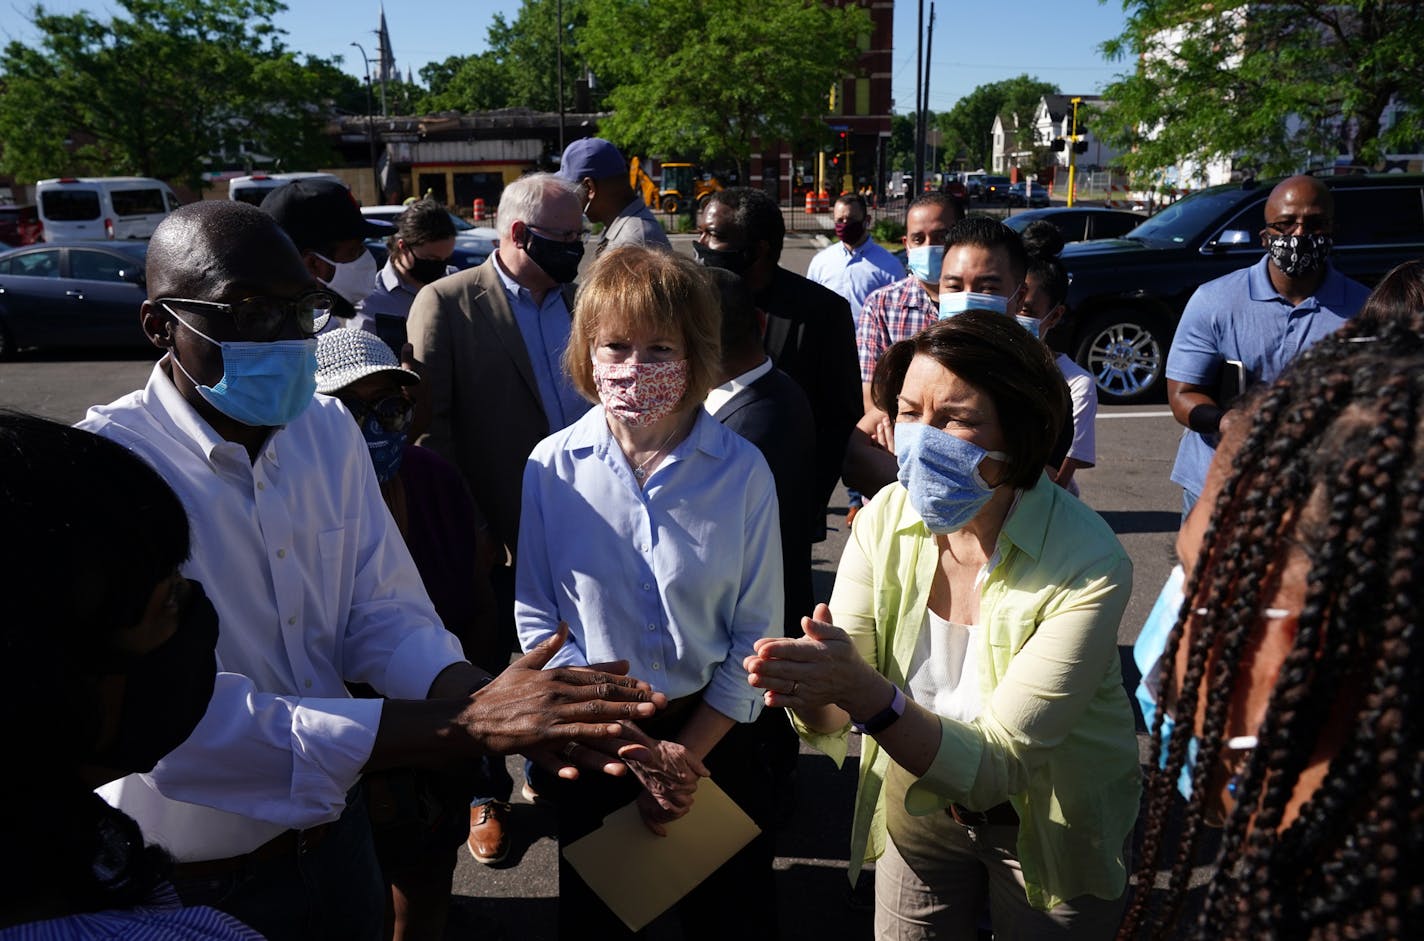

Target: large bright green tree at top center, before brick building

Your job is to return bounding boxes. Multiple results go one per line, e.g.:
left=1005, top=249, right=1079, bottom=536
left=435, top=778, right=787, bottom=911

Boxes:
left=580, top=0, right=870, bottom=172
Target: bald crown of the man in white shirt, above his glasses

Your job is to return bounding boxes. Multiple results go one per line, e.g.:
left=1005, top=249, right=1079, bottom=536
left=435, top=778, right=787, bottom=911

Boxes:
left=147, top=199, right=310, bottom=300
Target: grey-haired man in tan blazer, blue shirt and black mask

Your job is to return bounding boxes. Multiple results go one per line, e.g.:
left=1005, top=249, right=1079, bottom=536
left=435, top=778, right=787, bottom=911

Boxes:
left=407, top=174, right=590, bottom=864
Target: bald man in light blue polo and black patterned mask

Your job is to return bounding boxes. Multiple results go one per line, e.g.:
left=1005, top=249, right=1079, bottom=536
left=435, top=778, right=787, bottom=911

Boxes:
left=1166, top=175, right=1370, bottom=512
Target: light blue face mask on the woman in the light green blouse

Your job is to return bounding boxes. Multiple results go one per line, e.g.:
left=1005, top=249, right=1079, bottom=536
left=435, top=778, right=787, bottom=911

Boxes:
left=894, top=421, right=1008, bottom=535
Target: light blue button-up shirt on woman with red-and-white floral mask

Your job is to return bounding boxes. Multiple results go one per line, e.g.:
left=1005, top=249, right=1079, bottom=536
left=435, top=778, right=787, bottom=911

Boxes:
left=514, top=407, right=783, bottom=722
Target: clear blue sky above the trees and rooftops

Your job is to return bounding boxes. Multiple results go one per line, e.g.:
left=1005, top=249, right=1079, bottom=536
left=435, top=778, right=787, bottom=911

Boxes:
left=0, top=0, right=1131, bottom=114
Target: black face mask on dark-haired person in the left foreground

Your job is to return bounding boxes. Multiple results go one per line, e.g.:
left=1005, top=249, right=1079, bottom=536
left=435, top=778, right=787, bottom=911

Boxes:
left=93, top=582, right=218, bottom=772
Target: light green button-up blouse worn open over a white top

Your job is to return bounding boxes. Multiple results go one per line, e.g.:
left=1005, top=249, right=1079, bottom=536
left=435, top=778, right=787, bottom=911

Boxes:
left=793, top=477, right=1141, bottom=910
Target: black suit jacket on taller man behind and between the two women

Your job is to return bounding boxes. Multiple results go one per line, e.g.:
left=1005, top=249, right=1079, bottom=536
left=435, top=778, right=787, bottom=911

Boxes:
left=756, top=268, right=864, bottom=540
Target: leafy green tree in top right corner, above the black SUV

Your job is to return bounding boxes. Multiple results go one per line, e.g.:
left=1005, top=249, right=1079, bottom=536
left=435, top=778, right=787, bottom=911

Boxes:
left=1098, top=0, right=1424, bottom=175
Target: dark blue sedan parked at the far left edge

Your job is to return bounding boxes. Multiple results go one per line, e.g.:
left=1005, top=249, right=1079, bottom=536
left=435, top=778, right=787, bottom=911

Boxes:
left=0, top=241, right=150, bottom=359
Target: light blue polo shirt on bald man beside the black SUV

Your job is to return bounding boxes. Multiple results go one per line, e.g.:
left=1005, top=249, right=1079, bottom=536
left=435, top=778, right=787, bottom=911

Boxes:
left=1166, top=255, right=1370, bottom=494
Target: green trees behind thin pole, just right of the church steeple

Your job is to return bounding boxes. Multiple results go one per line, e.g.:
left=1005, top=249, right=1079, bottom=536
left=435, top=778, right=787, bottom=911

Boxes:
left=419, top=0, right=585, bottom=111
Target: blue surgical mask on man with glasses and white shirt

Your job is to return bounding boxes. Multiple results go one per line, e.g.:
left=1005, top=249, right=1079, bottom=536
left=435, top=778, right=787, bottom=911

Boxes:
left=168, top=307, right=316, bottom=429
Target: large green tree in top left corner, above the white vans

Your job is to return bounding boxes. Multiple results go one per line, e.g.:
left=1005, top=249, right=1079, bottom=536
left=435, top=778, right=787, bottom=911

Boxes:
left=0, top=0, right=353, bottom=188
